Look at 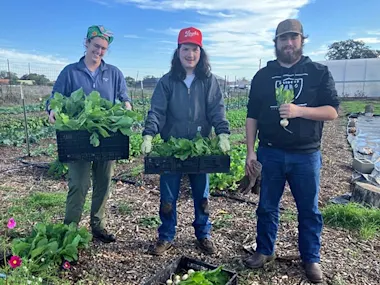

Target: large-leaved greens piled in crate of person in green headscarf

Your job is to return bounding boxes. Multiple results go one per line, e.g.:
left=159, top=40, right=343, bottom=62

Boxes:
left=50, top=88, right=141, bottom=147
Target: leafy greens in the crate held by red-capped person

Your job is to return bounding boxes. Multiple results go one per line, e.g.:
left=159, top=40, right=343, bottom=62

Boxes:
left=150, top=133, right=223, bottom=160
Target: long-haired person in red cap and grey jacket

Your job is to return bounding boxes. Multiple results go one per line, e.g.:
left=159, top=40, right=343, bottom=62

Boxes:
left=141, top=27, right=230, bottom=255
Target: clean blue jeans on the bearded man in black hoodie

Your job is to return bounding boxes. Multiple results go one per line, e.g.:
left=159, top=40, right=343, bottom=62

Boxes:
left=256, top=147, right=323, bottom=263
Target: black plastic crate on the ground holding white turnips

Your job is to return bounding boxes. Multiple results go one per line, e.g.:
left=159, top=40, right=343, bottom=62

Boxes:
left=144, top=256, right=238, bottom=285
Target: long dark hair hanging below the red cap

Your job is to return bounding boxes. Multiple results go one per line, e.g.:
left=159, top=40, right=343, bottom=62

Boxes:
left=170, top=45, right=211, bottom=81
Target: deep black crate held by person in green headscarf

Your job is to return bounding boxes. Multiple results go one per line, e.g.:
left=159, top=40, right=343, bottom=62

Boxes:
left=56, top=130, right=129, bottom=162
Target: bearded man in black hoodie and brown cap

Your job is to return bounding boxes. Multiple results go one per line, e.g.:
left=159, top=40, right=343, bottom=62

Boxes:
left=245, top=19, right=339, bottom=283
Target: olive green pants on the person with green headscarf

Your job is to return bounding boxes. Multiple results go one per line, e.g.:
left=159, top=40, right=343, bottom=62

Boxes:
left=64, top=161, right=114, bottom=229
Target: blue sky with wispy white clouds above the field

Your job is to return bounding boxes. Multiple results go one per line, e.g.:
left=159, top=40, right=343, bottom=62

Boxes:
left=0, top=0, right=380, bottom=81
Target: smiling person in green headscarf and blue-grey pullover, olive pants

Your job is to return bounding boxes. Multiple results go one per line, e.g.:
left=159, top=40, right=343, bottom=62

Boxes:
left=46, top=25, right=132, bottom=243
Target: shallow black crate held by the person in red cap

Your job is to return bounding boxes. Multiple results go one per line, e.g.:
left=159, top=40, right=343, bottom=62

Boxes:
left=144, top=155, right=230, bottom=174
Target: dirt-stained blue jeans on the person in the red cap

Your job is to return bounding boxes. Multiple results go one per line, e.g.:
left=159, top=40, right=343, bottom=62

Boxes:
left=158, top=174, right=211, bottom=241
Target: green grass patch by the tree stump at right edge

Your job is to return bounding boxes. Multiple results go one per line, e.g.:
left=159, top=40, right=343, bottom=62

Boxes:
left=322, top=203, right=380, bottom=240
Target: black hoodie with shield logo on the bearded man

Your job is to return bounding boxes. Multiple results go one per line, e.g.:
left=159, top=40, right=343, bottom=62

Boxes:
left=247, top=56, right=339, bottom=153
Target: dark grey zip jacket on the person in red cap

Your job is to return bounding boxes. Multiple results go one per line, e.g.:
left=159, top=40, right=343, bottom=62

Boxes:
left=142, top=72, right=230, bottom=141
